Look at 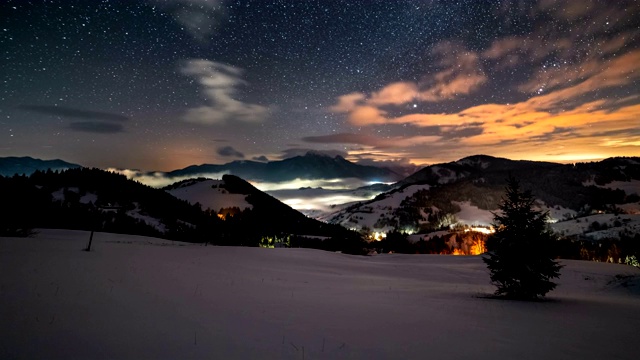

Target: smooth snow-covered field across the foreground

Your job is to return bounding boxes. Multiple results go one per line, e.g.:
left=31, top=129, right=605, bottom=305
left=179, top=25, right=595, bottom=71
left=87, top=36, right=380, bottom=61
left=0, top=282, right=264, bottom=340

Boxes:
left=0, top=230, right=640, bottom=359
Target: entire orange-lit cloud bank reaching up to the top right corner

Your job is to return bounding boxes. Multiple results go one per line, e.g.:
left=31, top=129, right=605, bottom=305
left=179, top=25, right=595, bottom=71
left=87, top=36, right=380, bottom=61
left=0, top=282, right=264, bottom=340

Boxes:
left=324, top=0, right=640, bottom=163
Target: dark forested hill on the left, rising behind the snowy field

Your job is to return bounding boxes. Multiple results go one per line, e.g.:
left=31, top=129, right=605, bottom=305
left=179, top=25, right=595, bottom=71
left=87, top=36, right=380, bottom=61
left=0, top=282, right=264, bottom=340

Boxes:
left=0, top=168, right=219, bottom=241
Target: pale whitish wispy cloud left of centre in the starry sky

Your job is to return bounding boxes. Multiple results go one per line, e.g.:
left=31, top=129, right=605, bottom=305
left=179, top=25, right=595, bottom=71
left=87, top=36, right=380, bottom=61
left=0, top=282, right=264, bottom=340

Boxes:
left=180, top=59, right=269, bottom=125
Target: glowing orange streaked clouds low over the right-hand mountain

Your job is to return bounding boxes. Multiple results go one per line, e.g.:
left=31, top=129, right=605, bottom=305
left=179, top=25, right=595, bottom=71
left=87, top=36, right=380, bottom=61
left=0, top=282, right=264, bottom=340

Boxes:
left=332, top=28, right=640, bottom=162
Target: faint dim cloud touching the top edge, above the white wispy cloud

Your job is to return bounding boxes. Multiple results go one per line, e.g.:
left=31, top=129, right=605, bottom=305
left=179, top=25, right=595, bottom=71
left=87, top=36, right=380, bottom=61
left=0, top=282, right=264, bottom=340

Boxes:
left=151, top=0, right=224, bottom=42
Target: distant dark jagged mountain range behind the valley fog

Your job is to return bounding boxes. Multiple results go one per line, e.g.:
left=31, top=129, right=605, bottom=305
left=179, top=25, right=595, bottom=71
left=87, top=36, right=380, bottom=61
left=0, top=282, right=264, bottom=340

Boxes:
left=166, top=152, right=401, bottom=182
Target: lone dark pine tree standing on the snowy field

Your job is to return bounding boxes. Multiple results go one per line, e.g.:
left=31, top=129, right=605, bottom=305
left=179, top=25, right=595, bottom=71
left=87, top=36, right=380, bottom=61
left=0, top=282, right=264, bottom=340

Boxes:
left=482, top=177, right=562, bottom=300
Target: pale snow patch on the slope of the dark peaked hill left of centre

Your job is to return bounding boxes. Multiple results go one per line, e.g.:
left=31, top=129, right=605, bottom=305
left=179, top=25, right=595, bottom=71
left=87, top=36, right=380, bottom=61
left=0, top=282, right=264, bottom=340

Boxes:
left=167, top=180, right=252, bottom=211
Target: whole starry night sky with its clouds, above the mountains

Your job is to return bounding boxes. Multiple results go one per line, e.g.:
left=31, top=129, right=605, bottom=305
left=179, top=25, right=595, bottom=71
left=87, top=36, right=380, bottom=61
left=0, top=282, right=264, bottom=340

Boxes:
left=0, top=0, right=640, bottom=171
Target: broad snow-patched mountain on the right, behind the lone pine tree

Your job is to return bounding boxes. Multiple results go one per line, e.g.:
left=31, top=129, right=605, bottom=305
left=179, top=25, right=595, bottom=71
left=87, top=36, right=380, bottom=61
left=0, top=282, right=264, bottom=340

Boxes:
left=328, top=155, right=640, bottom=239
